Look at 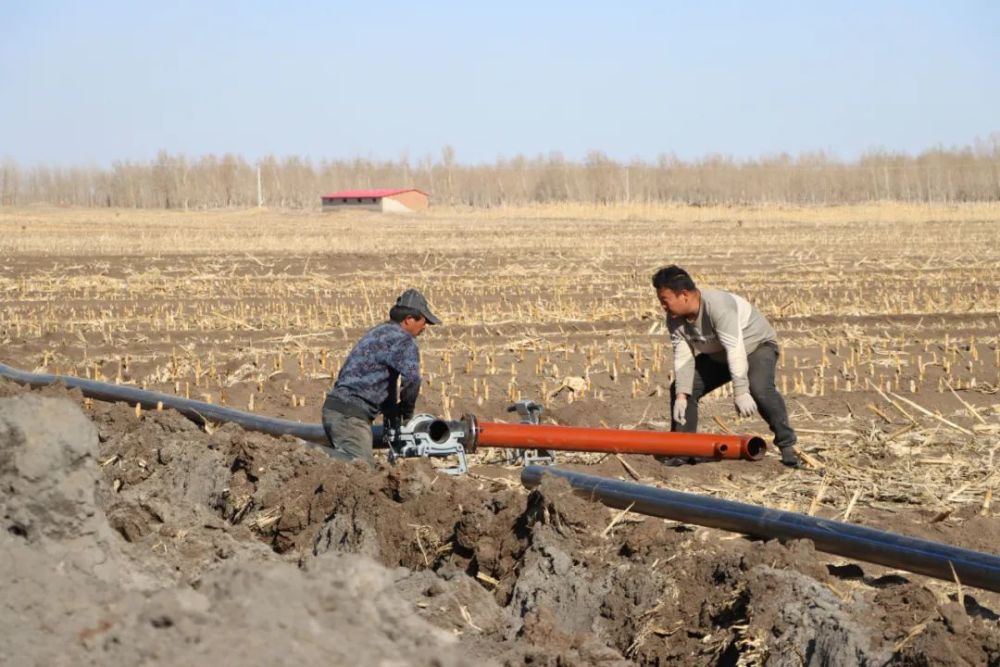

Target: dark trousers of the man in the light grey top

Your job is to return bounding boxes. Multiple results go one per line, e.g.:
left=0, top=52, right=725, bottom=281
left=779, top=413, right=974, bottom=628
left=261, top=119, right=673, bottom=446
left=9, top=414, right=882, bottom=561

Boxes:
left=670, top=343, right=797, bottom=447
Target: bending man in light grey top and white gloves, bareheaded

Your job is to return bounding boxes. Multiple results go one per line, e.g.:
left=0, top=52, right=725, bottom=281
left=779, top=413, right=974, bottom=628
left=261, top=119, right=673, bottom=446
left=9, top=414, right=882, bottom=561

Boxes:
left=653, top=265, right=799, bottom=467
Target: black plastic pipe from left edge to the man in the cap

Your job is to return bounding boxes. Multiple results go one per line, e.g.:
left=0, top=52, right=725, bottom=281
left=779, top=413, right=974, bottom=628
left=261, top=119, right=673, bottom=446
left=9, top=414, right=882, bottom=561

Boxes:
left=0, top=364, right=382, bottom=446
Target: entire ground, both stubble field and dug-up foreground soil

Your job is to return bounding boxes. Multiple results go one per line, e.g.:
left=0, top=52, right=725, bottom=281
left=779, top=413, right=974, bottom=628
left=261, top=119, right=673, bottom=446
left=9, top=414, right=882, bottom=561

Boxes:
left=0, top=205, right=1000, bottom=665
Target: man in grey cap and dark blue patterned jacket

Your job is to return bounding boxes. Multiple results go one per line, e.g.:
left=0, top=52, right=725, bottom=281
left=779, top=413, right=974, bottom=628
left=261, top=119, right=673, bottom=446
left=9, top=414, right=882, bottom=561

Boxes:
left=323, top=289, right=441, bottom=466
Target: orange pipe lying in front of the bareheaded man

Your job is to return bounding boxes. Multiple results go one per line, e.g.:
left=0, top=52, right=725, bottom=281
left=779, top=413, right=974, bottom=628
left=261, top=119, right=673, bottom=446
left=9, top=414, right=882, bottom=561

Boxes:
left=476, top=422, right=766, bottom=461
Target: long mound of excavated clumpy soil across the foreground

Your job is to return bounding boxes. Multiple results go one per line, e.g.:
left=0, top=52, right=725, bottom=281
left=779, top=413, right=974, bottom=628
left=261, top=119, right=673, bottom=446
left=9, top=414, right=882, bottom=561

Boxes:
left=0, top=385, right=1000, bottom=665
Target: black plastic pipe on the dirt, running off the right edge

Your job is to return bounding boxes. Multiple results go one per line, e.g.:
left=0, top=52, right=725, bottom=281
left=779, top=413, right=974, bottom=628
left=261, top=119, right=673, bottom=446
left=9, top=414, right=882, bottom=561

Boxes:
left=521, top=466, right=1000, bottom=592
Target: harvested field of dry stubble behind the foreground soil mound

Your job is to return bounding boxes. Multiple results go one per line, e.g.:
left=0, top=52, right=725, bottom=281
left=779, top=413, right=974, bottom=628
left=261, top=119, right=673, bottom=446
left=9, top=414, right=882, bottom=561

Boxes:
left=0, top=204, right=1000, bottom=521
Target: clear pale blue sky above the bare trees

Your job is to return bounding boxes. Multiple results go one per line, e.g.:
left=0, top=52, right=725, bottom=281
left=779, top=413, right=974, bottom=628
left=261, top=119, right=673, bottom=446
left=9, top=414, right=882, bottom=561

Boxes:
left=0, top=0, right=1000, bottom=165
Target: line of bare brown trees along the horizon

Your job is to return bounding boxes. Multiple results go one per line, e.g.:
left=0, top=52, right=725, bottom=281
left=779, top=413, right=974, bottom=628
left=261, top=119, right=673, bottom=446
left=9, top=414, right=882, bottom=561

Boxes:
left=0, top=134, right=1000, bottom=209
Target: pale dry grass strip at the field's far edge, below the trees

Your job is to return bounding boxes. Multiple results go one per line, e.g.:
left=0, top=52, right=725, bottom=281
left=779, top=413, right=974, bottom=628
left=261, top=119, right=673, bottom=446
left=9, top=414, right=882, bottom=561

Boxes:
left=0, top=203, right=1000, bottom=257
